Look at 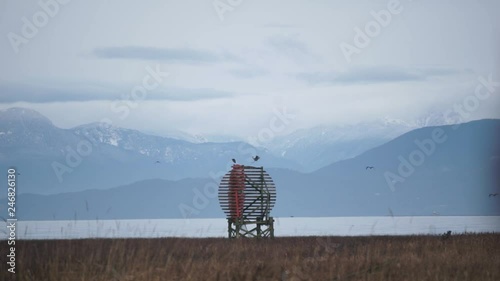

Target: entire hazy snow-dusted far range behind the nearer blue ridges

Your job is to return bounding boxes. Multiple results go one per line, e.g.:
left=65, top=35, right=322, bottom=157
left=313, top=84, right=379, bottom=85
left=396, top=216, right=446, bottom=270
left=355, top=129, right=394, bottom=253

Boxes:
left=0, top=108, right=430, bottom=194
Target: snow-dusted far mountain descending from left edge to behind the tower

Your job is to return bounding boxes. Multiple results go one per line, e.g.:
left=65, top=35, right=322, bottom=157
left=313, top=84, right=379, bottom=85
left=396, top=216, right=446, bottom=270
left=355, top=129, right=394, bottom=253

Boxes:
left=0, top=108, right=297, bottom=193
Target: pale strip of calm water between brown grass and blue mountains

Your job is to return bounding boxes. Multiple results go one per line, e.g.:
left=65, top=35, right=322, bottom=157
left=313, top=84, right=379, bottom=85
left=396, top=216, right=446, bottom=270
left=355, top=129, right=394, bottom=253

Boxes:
left=0, top=216, right=500, bottom=239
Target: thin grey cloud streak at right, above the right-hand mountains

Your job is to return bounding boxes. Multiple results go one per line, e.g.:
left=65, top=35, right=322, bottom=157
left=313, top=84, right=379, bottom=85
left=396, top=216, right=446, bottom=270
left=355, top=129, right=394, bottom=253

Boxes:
left=295, top=67, right=463, bottom=85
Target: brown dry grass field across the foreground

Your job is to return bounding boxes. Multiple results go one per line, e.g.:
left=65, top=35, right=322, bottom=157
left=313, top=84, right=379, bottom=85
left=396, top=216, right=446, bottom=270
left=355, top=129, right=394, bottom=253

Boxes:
left=0, top=234, right=500, bottom=281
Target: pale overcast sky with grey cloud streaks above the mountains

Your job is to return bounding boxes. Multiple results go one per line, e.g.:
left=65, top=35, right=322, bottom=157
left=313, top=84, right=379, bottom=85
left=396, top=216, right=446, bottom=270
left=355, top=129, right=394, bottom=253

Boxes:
left=0, top=0, right=500, bottom=138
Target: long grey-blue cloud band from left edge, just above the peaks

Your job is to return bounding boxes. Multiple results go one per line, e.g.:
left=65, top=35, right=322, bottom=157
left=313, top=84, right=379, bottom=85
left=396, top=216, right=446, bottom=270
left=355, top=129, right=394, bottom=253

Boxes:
left=0, top=84, right=234, bottom=103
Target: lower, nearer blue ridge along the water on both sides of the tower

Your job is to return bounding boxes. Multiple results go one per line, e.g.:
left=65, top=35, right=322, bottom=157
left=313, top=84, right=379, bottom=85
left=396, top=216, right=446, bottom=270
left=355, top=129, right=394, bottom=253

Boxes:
left=4, top=120, right=500, bottom=220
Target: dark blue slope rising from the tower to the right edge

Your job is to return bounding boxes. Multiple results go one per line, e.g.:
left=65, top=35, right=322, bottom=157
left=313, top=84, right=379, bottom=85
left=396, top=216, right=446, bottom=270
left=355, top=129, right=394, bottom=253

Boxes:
left=276, top=120, right=500, bottom=216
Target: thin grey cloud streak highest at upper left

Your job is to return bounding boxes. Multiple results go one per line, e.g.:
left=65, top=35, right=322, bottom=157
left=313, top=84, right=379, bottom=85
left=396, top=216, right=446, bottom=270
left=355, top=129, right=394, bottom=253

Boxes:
left=91, top=46, right=237, bottom=63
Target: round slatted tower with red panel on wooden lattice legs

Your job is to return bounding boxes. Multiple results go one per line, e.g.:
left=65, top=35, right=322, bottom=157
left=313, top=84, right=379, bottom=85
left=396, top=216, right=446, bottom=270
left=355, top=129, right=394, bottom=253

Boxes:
left=219, top=164, right=276, bottom=238
